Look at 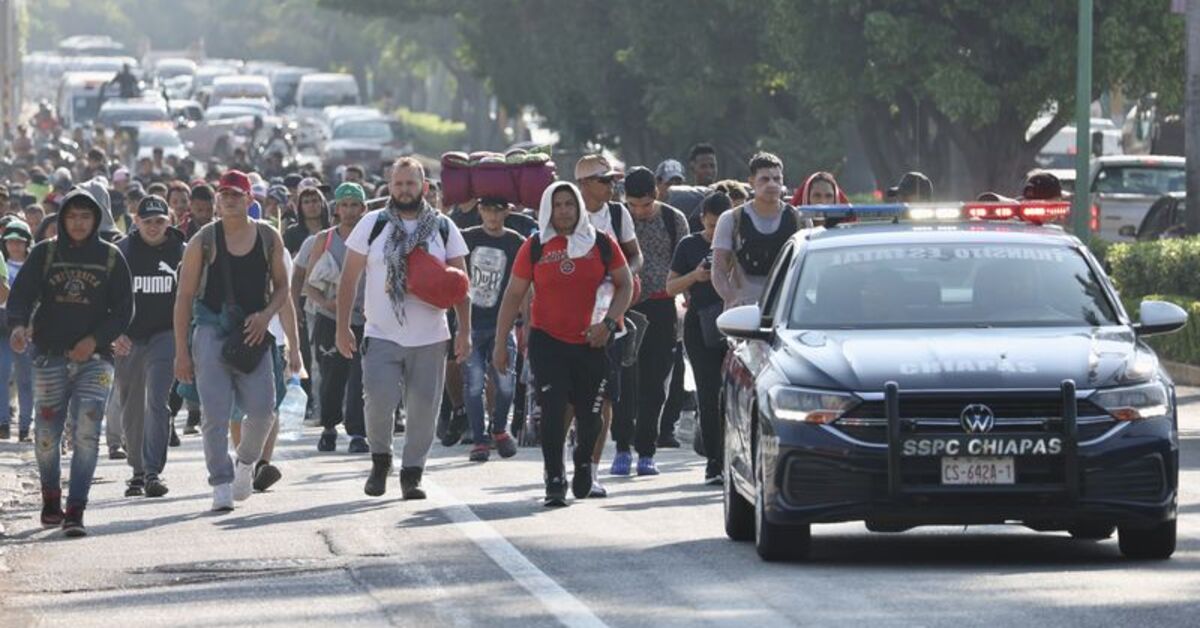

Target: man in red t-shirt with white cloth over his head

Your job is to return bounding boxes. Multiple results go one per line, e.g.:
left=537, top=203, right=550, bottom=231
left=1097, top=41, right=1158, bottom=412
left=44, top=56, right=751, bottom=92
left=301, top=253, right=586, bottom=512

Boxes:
left=492, top=183, right=634, bottom=508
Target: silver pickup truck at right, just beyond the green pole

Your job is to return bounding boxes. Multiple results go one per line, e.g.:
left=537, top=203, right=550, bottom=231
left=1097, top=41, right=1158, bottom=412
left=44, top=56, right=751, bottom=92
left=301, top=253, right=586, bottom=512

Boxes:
left=1091, top=155, right=1187, bottom=241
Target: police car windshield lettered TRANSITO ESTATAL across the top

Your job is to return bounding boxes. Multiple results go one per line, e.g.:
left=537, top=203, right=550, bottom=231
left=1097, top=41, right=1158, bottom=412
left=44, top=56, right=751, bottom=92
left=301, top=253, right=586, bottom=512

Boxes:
left=790, top=243, right=1117, bottom=329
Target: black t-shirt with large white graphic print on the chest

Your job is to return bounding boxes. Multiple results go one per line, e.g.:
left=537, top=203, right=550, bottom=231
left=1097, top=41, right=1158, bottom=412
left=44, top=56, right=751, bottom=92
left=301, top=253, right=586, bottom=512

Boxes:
left=462, top=227, right=524, bottom=329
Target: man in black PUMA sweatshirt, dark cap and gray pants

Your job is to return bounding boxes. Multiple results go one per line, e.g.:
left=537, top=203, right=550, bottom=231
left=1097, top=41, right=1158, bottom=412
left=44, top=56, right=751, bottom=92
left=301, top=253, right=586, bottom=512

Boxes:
left=113, top=196, right=186, bottom=497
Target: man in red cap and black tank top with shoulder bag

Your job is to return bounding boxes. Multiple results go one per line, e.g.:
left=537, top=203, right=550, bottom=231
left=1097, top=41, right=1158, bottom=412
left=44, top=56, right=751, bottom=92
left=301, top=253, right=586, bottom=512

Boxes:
left=174, top=171, right=301, bottom=512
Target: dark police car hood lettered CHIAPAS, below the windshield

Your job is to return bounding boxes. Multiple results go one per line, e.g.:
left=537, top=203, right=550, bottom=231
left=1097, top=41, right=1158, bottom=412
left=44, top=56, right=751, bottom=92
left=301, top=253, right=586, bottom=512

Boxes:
left=776, top=327, right=1146, bottom=391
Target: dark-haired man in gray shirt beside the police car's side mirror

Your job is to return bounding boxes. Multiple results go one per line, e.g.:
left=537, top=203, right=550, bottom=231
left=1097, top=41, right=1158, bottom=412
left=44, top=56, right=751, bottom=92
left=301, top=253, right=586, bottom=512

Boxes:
left=713, top=152, right=805, bottom=309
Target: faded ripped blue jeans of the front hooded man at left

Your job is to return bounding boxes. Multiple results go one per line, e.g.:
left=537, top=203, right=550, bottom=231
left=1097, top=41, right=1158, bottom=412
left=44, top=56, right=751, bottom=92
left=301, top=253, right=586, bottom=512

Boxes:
left=34, top=355, right=113, bottom=508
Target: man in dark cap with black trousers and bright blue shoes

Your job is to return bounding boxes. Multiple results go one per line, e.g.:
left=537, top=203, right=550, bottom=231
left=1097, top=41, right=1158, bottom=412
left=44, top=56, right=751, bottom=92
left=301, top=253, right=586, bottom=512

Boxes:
left=613, top=167, right=688, bottom=476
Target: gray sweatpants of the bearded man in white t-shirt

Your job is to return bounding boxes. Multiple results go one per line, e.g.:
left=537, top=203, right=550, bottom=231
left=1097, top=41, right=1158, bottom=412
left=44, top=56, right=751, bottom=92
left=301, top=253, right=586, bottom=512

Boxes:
left=362, top=337, right=450, bottom=467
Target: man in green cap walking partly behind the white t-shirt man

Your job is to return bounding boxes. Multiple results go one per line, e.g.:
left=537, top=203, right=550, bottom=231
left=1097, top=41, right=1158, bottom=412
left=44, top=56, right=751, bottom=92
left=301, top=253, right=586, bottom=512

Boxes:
left=304, top=183, right=371, bottom=454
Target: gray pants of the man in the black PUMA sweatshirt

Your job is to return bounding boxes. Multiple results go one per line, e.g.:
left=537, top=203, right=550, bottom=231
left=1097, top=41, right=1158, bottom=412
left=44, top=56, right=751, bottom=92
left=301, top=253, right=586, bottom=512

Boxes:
left=113, top=329, right=175, bottom=480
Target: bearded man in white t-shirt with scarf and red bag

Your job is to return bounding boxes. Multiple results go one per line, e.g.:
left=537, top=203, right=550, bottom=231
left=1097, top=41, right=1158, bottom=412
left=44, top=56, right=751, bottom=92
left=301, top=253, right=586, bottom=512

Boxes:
left=336, top=157, right=470, bottom=500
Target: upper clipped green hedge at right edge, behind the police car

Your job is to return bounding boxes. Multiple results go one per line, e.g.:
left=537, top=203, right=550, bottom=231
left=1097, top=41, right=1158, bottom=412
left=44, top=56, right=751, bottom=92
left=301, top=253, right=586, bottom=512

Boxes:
left=1105, top=238, right=1200, bottom=300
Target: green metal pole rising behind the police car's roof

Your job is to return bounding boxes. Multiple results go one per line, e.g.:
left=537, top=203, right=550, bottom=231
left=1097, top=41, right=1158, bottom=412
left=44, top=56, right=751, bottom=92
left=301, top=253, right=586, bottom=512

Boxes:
left=1070, top=0, right=1094, bottom=243
